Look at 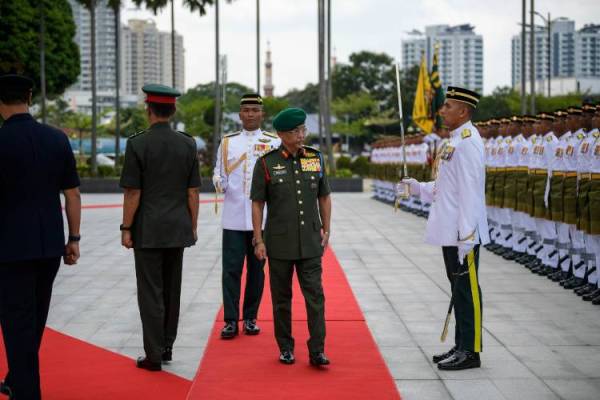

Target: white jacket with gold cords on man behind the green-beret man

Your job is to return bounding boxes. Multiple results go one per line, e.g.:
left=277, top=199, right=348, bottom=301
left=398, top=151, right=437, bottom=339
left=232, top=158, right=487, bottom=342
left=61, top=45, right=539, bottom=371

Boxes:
left=213, top=129, right=281, bottom=231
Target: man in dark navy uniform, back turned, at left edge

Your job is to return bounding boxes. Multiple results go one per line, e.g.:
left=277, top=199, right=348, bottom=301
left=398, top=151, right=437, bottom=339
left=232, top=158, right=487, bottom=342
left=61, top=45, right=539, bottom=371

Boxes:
left=0, top=75, right=81, bottom=400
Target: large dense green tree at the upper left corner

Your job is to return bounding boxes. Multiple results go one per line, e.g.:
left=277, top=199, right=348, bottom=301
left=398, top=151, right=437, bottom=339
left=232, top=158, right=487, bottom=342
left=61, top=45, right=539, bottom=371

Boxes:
left=0, top=0, right=80, bottom=98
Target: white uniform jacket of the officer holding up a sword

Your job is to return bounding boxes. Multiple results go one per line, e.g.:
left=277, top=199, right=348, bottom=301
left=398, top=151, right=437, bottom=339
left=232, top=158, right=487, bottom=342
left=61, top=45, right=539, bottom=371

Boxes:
left=420, top=121, right=490, bottom=246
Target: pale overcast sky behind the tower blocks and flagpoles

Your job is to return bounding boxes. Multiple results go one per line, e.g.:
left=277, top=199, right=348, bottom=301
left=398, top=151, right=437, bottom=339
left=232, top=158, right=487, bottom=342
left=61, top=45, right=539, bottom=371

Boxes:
left=122, top=0, right=600, bottom=95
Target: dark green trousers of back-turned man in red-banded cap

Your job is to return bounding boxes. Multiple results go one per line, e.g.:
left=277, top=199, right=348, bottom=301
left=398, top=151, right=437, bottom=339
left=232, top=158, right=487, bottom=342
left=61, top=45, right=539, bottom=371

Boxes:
left=134, top=247, right=183, bottom=362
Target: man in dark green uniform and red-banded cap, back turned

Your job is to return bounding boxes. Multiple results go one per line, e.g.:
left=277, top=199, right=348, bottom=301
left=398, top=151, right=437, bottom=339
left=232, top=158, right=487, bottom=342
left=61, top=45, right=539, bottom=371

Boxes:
left=120, top=84, right=200, bottom=371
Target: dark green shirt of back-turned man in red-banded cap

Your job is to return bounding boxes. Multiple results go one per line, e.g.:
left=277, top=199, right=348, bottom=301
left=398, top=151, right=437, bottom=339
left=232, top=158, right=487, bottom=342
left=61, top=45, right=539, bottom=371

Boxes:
left=120, top=122, right=200, bottom=249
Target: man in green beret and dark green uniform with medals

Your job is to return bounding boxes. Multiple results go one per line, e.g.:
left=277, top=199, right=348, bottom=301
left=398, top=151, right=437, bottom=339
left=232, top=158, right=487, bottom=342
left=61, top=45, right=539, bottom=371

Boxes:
left=250, top=108, right=331, bottom=366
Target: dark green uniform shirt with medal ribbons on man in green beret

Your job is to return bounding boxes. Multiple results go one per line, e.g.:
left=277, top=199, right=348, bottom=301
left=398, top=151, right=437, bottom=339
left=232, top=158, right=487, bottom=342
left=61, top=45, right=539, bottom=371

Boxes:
left=250, top=145, right=331, bottom=260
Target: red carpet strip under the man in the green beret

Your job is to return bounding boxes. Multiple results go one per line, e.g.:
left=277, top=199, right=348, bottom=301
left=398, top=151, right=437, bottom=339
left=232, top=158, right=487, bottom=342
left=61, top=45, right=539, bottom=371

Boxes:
left=188, top=249, right=400, bottom=400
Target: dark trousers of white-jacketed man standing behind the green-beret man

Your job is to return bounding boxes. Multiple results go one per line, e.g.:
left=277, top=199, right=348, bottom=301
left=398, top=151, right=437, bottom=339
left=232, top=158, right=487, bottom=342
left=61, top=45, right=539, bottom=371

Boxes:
left=222, top=229, right=265, bottom=321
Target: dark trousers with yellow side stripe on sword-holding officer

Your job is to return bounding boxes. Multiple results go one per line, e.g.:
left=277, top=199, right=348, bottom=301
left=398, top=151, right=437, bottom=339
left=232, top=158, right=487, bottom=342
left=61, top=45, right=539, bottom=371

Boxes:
left=442, top=245, right=483, bottom=353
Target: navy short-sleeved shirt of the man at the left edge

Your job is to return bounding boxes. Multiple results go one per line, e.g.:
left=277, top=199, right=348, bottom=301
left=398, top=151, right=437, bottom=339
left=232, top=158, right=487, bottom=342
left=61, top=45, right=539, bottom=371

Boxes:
left=0, top=114, right=79, bottom=262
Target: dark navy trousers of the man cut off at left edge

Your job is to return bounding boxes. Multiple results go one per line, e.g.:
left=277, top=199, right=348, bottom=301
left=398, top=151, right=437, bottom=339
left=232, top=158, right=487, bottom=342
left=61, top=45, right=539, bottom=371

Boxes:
left=0, top=257, right=60, bottom=400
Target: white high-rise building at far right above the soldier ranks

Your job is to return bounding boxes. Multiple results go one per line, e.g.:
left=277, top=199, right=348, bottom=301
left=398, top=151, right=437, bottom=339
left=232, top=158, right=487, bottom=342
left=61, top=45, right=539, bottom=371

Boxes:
left=511, top=18, right=600, bottom=95
